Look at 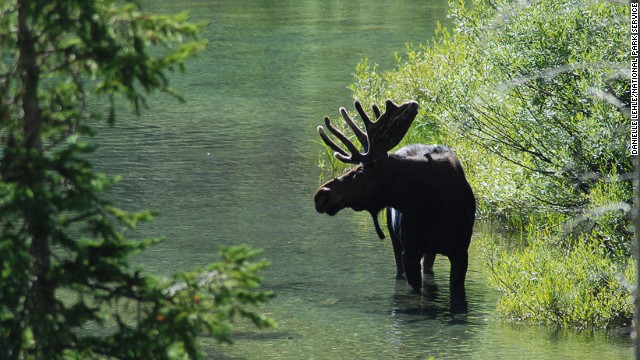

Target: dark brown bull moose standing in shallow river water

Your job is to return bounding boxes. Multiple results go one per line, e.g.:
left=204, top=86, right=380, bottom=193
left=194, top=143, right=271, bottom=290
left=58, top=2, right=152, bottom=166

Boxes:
left=314, top=100, right=476, bottom=311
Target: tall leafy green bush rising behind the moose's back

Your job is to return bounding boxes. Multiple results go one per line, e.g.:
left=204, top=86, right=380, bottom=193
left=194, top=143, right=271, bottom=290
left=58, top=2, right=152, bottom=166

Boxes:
left=352, top=1, right=631, bottom=216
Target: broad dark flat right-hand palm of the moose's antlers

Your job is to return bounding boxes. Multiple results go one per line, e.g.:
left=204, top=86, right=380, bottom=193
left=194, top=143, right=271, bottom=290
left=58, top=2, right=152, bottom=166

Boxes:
left=367, top=100, right=418, bottom=157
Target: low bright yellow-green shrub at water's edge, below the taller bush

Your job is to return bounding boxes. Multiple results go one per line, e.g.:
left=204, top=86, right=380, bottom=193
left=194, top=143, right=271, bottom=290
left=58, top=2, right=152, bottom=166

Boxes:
left=480, top=224, right=635, bottom=328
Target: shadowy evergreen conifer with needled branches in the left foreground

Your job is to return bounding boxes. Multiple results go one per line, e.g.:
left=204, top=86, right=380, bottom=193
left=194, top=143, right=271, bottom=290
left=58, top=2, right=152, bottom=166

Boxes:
left=0, top=0, right=272, bottom=359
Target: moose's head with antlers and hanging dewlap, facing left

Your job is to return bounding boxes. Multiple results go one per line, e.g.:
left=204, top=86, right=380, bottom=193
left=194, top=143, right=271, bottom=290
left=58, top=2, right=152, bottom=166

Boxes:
left=314, top=100, right=418, bottom=239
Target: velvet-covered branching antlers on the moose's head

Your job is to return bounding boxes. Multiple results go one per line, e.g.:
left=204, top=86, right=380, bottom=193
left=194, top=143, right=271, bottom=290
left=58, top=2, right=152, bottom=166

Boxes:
left=318, top=100, right=418, bottom=164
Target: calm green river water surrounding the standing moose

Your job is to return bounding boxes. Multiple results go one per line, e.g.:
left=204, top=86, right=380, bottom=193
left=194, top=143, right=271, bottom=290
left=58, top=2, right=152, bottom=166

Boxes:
left=89, top=0, right=632, bottom=359
